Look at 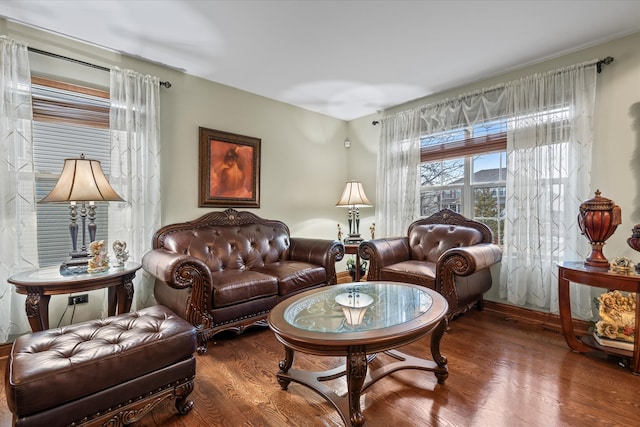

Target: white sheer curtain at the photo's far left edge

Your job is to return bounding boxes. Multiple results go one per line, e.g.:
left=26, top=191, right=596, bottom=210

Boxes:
left=0, top=37, right=38, bottom=342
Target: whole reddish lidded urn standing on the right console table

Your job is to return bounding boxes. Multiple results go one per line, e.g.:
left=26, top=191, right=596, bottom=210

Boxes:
left=578, top=190, right=622, bottom=268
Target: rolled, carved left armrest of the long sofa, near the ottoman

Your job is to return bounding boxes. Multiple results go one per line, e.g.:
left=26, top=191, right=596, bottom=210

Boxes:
left=142, top=249, right=213, bottom=329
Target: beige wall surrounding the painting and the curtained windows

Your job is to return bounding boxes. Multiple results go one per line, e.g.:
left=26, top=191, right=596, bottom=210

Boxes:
left=0, top=20, right=640, bottom=316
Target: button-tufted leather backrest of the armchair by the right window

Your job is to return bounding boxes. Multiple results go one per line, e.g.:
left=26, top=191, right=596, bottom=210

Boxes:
left=409, top=224, right=483, bottom=263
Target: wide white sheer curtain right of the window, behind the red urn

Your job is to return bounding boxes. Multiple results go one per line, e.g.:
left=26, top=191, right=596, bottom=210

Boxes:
left=500, top=64, right=596, bottom=319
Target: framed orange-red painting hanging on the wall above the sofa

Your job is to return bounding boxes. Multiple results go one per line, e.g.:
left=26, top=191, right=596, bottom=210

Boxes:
left=198, top=127, right=261, bottom=208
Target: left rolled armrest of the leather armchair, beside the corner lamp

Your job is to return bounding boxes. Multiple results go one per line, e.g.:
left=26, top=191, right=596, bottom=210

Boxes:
left=358, top=237, right=411, bottom=280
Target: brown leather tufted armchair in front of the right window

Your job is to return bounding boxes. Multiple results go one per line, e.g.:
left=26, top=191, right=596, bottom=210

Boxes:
left=358, top=209, right=502, bottom=318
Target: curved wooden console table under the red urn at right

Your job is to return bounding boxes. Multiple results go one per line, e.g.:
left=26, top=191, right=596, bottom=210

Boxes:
left=558, top=262, right=640, bottom=375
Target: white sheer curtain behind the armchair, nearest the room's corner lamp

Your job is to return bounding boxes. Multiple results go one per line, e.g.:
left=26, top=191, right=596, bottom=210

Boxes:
left=376, top=110, right=420, bottom=236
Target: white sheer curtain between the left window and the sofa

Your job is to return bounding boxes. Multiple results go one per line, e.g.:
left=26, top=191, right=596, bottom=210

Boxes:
left=108, top=68, right=160, bottom=309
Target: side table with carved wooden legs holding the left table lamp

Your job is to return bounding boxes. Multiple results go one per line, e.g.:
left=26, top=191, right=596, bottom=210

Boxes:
left=7, top=262, right=142, bottom=332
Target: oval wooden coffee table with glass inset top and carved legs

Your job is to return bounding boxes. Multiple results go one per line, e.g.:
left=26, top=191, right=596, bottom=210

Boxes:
left=269, top=282, right=449, bottom=426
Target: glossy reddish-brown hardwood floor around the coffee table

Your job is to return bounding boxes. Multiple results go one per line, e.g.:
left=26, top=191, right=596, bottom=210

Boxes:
left=0, top=310, right=640, bottom=427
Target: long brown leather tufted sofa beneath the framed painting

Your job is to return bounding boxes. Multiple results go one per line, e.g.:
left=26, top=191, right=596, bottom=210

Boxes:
left=142, top=209, right=344, bottom=353
